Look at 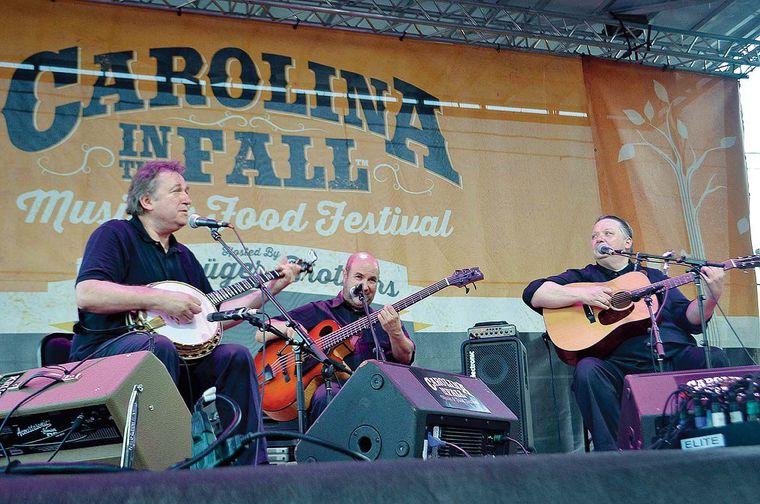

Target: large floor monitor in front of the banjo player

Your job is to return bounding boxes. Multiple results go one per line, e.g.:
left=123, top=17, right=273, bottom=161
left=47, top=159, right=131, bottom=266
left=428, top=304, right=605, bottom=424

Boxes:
left=0, top=352, right=191, bottom=470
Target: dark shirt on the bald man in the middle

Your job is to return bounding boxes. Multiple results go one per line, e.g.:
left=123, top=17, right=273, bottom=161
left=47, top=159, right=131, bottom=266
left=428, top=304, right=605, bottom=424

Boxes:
left=276, top=293, right=414, bottom=369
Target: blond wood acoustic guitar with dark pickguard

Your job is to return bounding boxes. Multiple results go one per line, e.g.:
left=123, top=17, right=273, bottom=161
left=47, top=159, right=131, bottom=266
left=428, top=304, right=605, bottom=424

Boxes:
left=543, top=255, right=760, bottom=366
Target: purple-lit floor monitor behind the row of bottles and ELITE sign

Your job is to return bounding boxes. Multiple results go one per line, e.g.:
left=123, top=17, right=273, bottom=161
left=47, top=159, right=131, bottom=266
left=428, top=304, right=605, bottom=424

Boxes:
left=618, top=366, right=760, bottom=450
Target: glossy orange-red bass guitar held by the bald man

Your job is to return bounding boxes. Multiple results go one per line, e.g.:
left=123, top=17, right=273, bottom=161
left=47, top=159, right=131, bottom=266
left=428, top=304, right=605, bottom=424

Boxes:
left=254, top=268, right=483, bottom=421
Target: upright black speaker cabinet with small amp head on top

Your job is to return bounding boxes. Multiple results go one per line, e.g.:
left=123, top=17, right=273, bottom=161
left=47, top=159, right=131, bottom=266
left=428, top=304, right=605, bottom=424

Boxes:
left=462, top=336, right=533, bottom=453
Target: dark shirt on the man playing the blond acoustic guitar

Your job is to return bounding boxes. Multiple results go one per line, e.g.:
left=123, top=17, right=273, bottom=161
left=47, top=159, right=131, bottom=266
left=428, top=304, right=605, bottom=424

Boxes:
left=523, top=263, right=702, bottom=344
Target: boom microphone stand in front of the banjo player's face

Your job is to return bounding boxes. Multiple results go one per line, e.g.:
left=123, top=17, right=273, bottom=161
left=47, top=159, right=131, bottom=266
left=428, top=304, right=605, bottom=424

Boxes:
left=206, top=229, right=351, bottom=434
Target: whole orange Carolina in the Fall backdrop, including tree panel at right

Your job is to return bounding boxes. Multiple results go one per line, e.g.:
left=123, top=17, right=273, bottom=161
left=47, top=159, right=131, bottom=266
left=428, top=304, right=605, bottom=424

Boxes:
left=0, top=0, right=757, bottom=346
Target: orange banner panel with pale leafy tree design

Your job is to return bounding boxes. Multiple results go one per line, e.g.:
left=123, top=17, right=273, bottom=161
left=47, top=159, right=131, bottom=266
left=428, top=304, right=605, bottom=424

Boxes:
left=583, top=58, right=757, bottom=346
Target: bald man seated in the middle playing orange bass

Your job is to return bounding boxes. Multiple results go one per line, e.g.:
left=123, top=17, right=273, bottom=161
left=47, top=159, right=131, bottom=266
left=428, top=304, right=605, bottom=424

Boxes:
left=257, top=252, right=414, bottom=425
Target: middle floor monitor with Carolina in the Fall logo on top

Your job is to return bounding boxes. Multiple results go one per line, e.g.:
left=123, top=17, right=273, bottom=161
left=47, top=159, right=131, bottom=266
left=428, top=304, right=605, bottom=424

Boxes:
left=296, top=360, right=517, bottom=463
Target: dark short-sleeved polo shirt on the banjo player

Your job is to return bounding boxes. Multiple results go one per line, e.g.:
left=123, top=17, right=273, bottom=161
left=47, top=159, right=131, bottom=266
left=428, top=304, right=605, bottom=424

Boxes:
left=74, top=217, right=212, bottom=346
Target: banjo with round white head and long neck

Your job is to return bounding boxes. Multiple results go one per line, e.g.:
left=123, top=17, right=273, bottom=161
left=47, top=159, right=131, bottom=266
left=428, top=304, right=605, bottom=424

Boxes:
left=127, top=259, right=313, bottom=361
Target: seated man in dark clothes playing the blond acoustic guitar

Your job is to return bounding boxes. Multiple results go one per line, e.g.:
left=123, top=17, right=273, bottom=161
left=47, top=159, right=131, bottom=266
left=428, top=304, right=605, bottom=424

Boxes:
left=523, top=215, right=729, bottom=450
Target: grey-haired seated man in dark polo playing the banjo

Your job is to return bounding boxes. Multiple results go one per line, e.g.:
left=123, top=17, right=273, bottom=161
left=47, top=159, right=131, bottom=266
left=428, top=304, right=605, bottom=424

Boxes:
left=71, top=161, right=300, bottom=463
